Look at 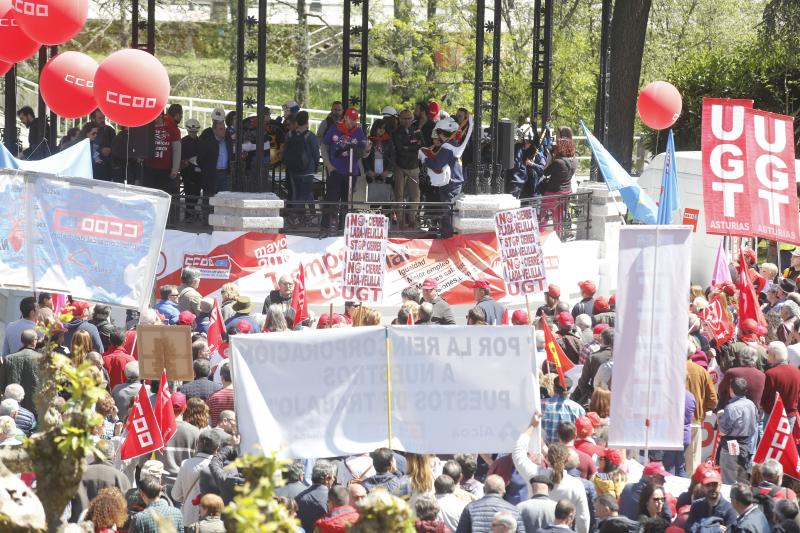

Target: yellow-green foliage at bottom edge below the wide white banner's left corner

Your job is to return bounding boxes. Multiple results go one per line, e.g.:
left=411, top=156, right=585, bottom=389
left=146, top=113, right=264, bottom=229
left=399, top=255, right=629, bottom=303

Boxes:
left=225, top=448, right=299, bottom=533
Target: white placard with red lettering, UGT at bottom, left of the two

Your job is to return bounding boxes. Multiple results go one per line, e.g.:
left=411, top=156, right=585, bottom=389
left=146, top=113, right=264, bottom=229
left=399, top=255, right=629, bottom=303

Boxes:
left=342, top=213, right=389, bottom=303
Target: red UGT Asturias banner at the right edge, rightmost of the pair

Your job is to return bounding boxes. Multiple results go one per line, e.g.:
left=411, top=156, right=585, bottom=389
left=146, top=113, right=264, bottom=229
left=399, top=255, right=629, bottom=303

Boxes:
left=745, top=109, right=800, bottom=243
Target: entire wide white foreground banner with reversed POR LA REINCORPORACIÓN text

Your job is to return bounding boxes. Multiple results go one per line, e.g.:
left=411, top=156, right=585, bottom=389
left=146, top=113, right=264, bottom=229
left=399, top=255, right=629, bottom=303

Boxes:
left=231, top=326, right=538, bottom=458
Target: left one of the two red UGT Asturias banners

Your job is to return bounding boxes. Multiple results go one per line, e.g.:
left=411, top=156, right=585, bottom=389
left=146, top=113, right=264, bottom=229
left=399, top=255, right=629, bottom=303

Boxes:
left=702, top=98, right=754, bottom=237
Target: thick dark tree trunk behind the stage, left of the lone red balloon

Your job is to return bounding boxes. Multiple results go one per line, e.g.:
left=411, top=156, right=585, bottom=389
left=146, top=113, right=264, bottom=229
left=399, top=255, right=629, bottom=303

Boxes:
left=607, top=0, right=652, bottom=170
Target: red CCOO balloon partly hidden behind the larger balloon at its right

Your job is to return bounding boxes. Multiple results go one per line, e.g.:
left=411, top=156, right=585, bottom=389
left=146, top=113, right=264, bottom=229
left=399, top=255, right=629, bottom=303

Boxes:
left=39, top=52, right=97, bottom=118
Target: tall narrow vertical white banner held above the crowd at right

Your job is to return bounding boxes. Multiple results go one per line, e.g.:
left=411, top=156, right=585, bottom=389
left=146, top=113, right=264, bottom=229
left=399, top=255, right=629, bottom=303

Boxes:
left=608, top=226, right=692, bottom=450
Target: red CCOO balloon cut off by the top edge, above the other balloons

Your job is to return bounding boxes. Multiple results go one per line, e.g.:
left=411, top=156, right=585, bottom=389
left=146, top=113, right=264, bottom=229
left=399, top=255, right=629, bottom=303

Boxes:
left=14, top=0, right=89, bottom=46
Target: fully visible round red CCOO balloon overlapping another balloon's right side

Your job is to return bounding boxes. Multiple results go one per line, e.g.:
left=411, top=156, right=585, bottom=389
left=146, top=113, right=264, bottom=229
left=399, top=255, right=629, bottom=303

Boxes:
left=94, top=48, right=170, bottom=128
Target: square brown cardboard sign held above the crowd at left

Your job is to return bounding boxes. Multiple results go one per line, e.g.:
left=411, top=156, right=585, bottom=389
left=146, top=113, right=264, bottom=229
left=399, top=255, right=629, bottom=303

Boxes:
left=136, top=324, right=194, bottom=381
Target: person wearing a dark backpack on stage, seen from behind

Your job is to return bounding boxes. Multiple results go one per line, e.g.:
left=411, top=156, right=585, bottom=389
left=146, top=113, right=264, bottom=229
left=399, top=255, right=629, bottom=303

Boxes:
left=283, top=111, right=319, bottom=225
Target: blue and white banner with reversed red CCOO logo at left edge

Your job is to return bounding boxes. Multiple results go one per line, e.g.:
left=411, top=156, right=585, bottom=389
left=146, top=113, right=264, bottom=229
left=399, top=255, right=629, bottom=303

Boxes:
left=0, top=171, right=170, bottom=308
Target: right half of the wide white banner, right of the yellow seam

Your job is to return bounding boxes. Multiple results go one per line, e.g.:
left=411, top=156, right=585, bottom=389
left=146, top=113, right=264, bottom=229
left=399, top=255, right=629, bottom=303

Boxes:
left=389, top=326, right=541, bottom=454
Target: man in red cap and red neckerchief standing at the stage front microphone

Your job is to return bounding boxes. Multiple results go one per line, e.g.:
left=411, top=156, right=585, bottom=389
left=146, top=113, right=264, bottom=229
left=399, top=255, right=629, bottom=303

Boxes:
left=320, top=107, right=370, bottom=237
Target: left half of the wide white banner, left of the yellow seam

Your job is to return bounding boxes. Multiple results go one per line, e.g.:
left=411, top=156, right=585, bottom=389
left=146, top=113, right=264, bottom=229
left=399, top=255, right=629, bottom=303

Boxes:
left=230, top=326, right=389, bottom=458
